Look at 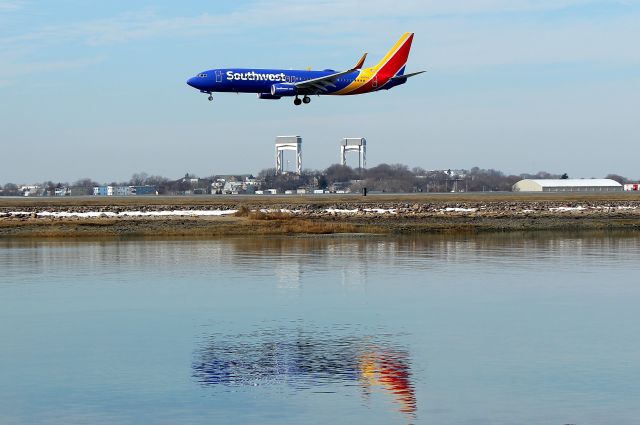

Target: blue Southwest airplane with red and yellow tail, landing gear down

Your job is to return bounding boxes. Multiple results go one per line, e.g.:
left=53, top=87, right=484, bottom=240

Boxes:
left=187, top=33, right=425, bottom=105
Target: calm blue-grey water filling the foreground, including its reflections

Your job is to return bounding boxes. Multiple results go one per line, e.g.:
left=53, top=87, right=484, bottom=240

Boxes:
left=0, top=235, right=640, bottom=425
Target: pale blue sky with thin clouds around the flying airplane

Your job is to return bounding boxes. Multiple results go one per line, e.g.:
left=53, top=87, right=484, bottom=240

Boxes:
left=0, top=0, right=640, bottom=184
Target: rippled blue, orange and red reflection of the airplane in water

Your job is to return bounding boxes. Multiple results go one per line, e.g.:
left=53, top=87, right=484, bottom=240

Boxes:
left=192, top=330, right=417, bottom=419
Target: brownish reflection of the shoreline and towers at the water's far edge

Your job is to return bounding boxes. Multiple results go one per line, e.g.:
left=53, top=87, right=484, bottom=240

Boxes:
left=0, top=232, right=640, bottom=278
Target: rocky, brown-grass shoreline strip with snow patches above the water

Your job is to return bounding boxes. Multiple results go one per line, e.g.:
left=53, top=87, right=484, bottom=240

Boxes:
left=0, top=193, right=640, bottom=238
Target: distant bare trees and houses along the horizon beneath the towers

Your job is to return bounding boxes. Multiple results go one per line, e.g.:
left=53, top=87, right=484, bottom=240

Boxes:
left=0, top=168, right=631, bottom=196
